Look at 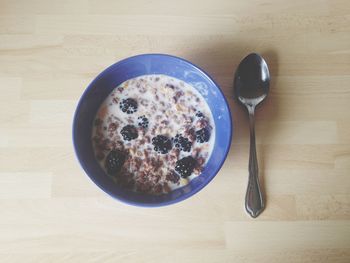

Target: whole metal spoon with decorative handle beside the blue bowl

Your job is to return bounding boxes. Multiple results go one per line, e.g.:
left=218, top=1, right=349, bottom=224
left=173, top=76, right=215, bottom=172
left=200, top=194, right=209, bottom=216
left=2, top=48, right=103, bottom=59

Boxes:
left=234, top=53, right=270, bottom=218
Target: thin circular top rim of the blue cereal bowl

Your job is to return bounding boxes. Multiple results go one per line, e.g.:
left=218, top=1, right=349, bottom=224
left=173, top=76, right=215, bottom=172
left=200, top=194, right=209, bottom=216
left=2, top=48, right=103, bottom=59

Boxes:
left=72, top=53, right=234, bottom=207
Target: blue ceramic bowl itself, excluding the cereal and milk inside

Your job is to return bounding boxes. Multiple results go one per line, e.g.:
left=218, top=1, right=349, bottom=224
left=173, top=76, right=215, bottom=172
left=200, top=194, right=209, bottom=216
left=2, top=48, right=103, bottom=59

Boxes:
left=73, top=54, right=232, bottom=206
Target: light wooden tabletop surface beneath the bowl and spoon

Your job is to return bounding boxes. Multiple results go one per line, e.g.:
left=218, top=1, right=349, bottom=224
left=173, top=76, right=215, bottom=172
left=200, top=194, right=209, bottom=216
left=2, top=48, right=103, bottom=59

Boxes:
left=0, top=0, right=350, bottom=263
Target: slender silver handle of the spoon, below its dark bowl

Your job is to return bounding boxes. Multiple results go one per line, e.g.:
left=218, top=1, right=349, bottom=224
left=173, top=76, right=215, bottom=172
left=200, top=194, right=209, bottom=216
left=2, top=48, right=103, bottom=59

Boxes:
left=245, top=106, right=265, bottom=218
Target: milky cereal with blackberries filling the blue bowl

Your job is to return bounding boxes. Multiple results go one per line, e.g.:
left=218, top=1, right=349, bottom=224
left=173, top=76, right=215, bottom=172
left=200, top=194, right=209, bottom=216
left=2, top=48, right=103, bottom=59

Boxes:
left=92, top=75, right=215, bottom=194
